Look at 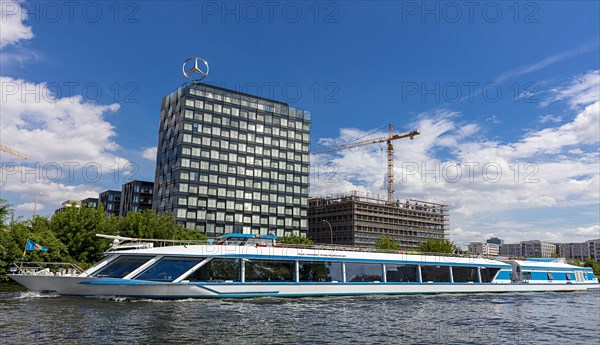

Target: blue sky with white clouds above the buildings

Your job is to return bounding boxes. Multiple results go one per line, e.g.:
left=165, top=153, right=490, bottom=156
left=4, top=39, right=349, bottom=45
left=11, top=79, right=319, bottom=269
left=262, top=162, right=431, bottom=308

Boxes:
left=0, top=0, right=600, bottom=242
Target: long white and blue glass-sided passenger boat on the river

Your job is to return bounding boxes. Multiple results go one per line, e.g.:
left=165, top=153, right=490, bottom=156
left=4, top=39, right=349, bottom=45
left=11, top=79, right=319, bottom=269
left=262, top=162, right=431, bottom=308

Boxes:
left=9, top=234, right=600, bottom=299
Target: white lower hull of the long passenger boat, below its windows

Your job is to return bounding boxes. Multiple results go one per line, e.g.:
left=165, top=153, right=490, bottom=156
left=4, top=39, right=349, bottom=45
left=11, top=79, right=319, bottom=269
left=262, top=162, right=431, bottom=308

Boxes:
left=9, top=275, right=600, bottom=299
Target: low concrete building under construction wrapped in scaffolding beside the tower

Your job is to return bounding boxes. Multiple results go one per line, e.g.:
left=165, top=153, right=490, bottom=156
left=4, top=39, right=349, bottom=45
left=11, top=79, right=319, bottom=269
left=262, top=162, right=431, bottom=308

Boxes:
left=308, top=192, right=449, bottom=250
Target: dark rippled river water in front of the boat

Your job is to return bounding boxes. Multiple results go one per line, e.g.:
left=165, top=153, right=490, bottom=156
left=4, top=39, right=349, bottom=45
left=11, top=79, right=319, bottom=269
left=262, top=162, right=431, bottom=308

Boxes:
left=0, top=283, right=600, bottom=344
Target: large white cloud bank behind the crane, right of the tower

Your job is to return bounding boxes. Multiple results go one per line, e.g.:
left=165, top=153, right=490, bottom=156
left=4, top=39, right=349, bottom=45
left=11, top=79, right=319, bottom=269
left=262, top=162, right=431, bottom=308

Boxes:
left=311, top=71, right=600, bottom=241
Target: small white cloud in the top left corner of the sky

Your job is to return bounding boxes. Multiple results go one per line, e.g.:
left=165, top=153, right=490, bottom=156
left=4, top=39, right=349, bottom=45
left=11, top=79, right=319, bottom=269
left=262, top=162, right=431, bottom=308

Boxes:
left=0, top=0, right=33, bottom=48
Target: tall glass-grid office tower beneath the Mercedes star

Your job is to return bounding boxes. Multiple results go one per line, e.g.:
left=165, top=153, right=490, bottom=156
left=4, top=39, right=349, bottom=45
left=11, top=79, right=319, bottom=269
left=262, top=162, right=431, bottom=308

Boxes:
left=154, top=83, right=311, bottom=236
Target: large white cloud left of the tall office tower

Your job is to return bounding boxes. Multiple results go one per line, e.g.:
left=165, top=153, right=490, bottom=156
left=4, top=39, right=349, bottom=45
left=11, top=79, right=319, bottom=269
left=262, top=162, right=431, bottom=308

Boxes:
left=0, top=77, right=127, bottom=167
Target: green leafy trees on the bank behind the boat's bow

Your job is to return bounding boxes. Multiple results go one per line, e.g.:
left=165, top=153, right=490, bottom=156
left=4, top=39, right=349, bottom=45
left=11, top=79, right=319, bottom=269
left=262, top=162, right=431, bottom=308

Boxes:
left=0, top=203, right=206, bottom=281
